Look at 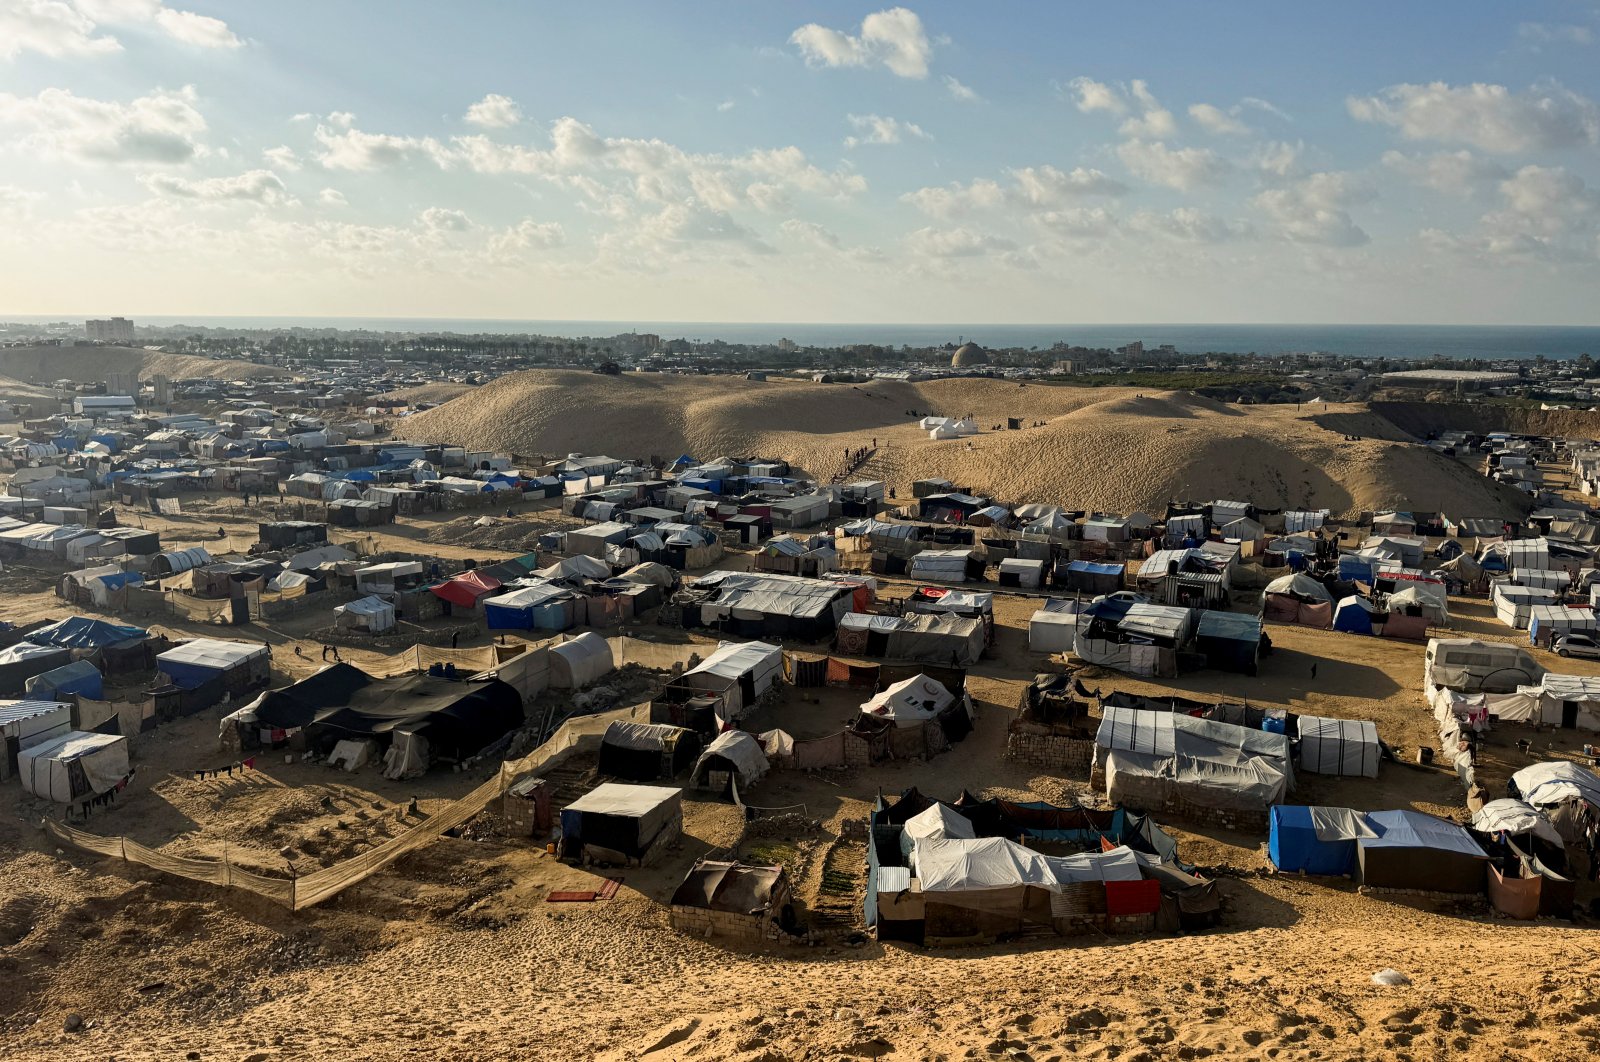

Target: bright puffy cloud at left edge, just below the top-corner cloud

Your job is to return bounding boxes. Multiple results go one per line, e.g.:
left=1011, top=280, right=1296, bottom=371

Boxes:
left=0, top=86, right=206, bottom=163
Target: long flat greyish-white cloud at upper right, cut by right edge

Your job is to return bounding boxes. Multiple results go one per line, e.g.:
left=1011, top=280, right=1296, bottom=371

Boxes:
left=1346, top=82, right=1600, bottom=155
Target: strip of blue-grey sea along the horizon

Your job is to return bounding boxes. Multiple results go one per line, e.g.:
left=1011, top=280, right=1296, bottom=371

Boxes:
left=11, top=315, right=1600, bottom=360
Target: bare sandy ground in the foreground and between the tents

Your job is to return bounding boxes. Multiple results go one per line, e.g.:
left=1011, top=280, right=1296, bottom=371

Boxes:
left=0, top=419, right=1600, bottom=1062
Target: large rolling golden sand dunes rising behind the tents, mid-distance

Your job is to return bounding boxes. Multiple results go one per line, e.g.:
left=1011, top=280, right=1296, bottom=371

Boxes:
left=405, top=371, right=1525, bottom=517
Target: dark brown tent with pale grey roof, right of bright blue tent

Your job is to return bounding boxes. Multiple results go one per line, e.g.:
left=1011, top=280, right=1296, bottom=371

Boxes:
left=1355, top=809, right=1488, bottom=894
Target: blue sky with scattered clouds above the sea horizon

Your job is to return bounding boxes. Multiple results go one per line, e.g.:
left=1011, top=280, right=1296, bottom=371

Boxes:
left=0, top=0, right=1600, bottom=325
